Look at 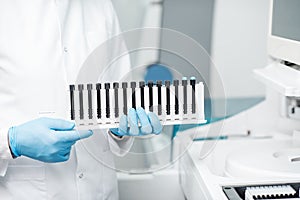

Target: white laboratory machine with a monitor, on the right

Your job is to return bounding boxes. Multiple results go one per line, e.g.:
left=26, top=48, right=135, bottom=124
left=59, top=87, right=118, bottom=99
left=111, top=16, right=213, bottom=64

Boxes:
left=180, top=0, right=300, bottom=200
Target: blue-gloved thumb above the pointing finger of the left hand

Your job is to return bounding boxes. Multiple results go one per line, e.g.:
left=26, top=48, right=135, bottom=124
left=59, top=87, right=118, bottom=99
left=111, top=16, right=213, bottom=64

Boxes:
left=40, top=118, right=75, bottom=131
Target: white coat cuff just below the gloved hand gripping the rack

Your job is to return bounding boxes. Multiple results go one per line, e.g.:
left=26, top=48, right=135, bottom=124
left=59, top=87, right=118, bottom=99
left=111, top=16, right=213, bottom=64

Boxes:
left=108, top=131, right=134, bottom=156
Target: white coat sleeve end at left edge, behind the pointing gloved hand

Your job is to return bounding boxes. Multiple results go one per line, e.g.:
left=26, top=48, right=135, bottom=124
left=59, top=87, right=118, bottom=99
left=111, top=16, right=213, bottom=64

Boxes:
left=0, top=128, right=12, bottom=176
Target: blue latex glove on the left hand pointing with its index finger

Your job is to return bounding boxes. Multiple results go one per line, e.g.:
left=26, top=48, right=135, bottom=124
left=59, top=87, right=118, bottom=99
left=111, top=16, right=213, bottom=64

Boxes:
left=8, top=118, right=93, bottom=163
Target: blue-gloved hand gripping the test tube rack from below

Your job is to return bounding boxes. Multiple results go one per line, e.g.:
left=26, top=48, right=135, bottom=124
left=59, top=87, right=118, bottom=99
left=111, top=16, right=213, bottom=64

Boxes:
left=110, top=108, right=162, bottom=136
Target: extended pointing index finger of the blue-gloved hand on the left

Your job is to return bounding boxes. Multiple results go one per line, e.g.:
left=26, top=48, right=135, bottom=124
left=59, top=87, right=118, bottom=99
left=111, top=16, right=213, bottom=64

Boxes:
left=55, top=130, right=93, bottom=142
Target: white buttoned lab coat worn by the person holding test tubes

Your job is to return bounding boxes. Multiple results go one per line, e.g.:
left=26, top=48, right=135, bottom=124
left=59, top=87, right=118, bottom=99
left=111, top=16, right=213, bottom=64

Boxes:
left=0, top=0, right=132, bottom=200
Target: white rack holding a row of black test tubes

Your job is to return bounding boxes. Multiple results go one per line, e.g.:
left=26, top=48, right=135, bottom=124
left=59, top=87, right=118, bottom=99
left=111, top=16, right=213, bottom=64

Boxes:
left=70, top=78, right=205, bottom=128
